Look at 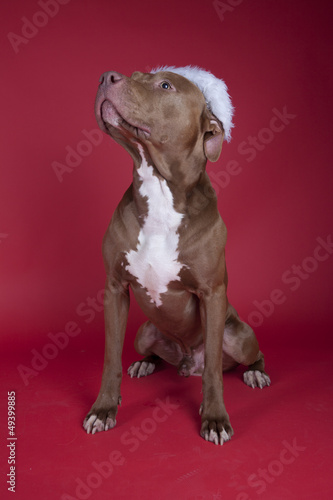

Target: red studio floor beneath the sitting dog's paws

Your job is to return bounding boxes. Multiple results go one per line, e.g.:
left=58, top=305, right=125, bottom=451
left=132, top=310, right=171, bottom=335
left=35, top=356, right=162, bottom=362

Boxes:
left=0, top=326, right=333, bottom=500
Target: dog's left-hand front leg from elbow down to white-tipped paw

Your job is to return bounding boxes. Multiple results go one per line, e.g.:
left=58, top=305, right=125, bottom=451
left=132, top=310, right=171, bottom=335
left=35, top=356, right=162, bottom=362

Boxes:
left=83, top=278, right=129, bottom=434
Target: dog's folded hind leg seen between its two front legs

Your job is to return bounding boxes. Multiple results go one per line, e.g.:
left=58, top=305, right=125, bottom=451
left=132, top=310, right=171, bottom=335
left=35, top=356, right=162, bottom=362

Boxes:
left=127, top=321, right=182, bottom=378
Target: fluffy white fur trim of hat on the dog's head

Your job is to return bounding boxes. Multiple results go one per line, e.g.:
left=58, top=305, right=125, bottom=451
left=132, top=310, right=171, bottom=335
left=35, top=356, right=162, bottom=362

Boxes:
left=151, top=66, right=234, bottom=142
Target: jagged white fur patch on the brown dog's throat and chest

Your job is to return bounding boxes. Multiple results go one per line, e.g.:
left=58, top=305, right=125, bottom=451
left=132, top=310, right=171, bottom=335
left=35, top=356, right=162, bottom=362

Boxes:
left=126, top=145, right=183, bottom=307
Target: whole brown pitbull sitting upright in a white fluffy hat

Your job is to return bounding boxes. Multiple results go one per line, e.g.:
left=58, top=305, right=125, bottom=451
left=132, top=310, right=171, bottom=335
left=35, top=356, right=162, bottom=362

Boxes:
left=83, top=67, right=270, bottom=444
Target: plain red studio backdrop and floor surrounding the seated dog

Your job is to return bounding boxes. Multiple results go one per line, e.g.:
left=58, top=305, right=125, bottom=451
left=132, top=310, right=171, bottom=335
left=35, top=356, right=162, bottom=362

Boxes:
left=0, top=0, right=333, bottom=500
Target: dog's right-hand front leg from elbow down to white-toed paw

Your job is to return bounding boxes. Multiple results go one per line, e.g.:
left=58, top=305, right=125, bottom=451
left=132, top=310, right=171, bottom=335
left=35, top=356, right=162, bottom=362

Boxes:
left=200, top=285, right=233, bottom=444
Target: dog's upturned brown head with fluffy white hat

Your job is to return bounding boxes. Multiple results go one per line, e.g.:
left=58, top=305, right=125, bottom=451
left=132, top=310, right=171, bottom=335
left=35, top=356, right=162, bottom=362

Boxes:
left=95, top=66, right=233, bottom=174
